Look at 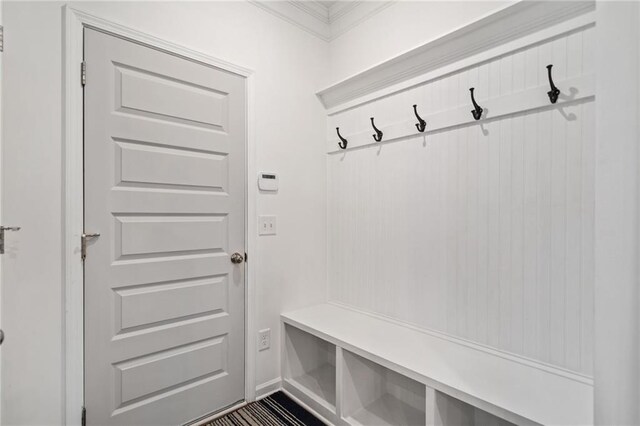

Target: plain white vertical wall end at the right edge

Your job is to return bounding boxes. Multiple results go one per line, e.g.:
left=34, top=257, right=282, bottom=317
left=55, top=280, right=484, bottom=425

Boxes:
left=594, top=2, right=640, bottom=425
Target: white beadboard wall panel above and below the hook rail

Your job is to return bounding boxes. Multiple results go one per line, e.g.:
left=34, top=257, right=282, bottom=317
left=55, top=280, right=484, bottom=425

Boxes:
left=327, top=27, right=595, bottom=375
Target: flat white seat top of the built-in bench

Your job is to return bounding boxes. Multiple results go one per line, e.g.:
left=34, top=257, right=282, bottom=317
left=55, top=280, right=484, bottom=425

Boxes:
left=281, top=303, right=593, bottom=425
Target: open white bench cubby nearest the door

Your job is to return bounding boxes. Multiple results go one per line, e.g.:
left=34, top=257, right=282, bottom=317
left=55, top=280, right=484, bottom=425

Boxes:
left=284, top=325, right=336, bottom=412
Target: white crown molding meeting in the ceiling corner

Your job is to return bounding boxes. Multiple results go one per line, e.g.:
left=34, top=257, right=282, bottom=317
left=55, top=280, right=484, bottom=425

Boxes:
left=248, top=0, right=394, bottom=42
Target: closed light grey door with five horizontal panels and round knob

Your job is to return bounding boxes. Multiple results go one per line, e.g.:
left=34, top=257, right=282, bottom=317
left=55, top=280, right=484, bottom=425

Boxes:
left=84, top=29, right=246, bottom=425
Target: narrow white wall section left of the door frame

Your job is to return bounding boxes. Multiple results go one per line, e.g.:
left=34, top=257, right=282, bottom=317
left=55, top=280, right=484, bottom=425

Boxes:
left=1, top=3, right=63, bottom=425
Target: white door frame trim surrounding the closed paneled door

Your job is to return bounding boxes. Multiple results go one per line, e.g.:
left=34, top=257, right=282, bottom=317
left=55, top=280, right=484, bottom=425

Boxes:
left=62, top=6, right=257, bottom=426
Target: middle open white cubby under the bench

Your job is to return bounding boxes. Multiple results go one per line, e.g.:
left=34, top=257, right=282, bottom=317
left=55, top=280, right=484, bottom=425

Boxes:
left=342, top=351, right=426, bottom=426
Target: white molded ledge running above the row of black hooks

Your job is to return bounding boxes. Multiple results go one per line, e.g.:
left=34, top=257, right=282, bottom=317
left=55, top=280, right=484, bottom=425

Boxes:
left=316, top=1, right=595, bottom=110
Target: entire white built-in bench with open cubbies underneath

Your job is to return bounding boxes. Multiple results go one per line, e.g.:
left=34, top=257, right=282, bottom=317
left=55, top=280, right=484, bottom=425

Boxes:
left=281, top=304, right=593, bottom=425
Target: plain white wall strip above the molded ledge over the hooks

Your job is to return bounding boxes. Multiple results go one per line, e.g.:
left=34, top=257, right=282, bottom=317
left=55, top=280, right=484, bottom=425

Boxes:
left=329, top=0, right=512, bottom=83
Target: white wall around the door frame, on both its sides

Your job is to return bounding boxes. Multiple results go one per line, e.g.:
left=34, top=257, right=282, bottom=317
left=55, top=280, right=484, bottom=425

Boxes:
left=1, top=2, right=328, bottom=425
